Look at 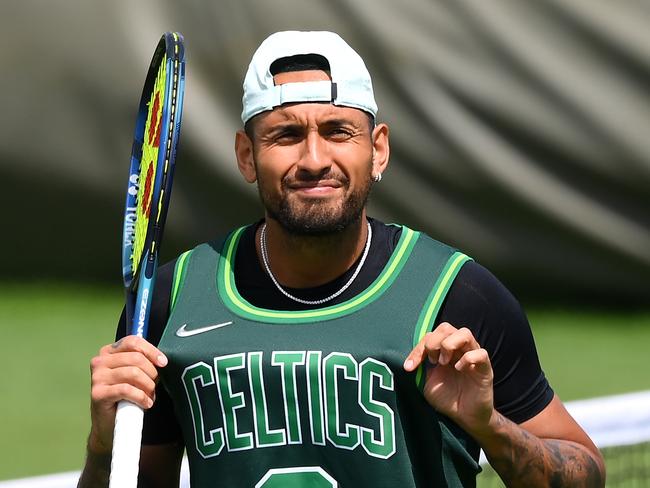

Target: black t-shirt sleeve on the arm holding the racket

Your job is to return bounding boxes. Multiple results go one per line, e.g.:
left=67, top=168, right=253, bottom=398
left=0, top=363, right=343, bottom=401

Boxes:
left=116, top=260, right=182, bottom=444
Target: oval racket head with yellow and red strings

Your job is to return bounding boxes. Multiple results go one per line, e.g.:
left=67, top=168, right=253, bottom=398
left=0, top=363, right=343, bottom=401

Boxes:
left=122, top=32, right=185, bottom=292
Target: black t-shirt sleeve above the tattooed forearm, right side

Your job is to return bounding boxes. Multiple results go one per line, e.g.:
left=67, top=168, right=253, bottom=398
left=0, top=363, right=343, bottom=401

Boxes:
left=438, top=261, right=553, bottom=423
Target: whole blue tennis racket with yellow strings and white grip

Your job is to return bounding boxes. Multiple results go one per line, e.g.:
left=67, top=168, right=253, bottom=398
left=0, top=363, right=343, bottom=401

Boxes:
left=110, top=32, right=185, bottom=488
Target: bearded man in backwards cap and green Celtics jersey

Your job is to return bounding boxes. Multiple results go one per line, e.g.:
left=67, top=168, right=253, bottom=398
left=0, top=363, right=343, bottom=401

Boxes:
left=80, top=32, right=604, bottom=488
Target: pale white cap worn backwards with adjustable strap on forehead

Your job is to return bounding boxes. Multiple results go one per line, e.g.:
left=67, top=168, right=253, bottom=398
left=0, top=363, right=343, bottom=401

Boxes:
left=241, top=31, right=377, bottom=124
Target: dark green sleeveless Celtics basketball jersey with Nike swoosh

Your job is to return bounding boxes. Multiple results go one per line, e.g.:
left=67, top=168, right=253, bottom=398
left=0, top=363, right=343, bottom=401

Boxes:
left=159, top=227, right=479, bottom=488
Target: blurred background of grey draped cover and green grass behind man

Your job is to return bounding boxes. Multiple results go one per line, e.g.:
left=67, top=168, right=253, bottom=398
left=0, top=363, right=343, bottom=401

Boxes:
left=0, top=0, right=650, bottom=479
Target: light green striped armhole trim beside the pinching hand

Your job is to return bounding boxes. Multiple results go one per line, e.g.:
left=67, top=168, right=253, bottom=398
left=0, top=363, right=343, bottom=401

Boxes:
left=413, top=252, right=472, bottom=391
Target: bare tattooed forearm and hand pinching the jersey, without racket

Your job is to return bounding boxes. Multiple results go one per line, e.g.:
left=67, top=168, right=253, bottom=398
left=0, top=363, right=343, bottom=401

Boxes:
left=404, top=323, right=605, bottom=488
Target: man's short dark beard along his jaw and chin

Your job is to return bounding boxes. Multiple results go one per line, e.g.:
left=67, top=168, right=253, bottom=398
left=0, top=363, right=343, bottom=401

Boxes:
left=258, top=171, right=372, bottom=236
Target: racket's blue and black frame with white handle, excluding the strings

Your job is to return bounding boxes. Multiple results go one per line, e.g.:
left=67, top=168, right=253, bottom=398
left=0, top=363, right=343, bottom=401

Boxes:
left=109, top=32, right=185, bottom=488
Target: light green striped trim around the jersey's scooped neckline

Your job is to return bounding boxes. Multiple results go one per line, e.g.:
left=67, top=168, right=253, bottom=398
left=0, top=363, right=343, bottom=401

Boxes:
left=217, top=227, right=420, bottom=324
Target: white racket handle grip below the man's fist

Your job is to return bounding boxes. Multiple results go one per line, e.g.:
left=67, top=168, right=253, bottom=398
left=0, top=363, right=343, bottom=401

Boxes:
left=109, top=400, right=144, bottom=488
